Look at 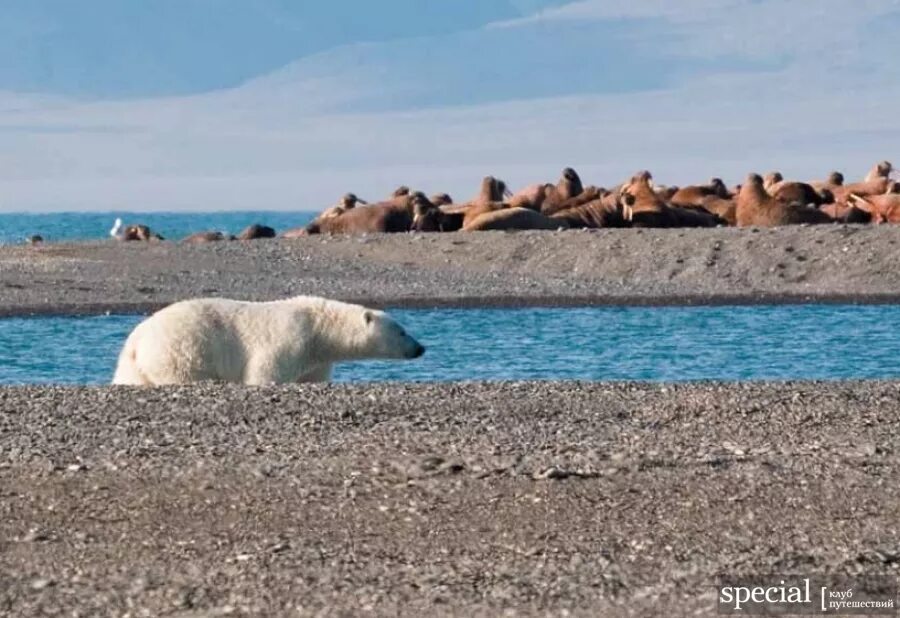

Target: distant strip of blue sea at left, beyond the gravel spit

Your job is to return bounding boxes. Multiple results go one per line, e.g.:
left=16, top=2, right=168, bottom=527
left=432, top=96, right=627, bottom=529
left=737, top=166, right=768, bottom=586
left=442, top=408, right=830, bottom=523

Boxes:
left=0, top=211, right=315, bottom=245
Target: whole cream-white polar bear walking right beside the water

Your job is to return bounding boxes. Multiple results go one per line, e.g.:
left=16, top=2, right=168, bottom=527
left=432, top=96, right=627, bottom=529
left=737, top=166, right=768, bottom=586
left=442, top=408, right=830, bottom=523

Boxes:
left=112, top=296, right=425, bottom=386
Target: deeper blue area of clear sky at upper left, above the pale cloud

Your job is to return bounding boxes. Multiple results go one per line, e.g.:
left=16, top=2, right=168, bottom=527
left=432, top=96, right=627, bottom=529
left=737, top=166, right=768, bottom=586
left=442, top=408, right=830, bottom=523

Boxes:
left=0, top=0, right=563, bottom=97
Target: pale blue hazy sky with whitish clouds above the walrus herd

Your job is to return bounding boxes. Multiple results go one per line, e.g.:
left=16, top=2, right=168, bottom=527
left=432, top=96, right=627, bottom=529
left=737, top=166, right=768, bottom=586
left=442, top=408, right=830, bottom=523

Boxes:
left=0, top=0, right=900, bottom=212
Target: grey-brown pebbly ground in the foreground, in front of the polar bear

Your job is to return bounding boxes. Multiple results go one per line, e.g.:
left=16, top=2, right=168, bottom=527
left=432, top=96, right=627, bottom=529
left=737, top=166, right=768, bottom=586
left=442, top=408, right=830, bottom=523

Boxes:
left=0, top=382, right=900, bottom=616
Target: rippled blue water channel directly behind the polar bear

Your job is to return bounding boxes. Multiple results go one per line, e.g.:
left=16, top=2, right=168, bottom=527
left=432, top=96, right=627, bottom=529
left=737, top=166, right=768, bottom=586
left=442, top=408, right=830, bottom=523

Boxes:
left=0, top=305, right=900, bottom=384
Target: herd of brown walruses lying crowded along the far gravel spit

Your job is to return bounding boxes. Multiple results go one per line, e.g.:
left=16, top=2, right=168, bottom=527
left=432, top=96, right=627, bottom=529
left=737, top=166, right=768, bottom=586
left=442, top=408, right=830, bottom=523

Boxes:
left=103, top=161, right=900, bottom=243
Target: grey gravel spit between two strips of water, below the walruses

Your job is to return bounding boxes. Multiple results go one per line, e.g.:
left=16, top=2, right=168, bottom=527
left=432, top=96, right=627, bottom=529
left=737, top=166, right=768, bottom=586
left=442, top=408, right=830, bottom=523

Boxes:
left=0, top=225, right=900, bottom=316
